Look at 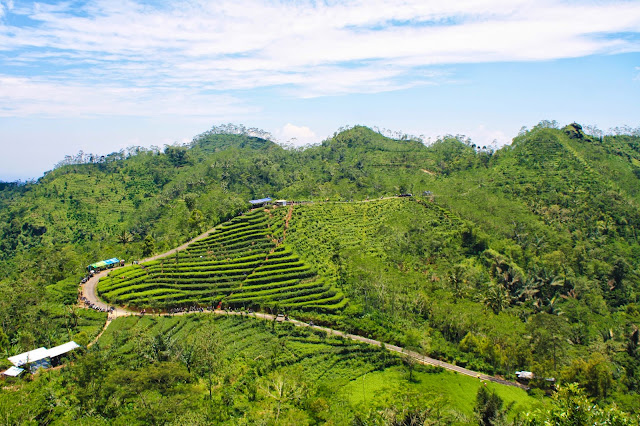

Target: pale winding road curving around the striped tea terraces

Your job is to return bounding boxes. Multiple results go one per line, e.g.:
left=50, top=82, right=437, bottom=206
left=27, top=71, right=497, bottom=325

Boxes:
left=79, top=203, right=529, bottom=390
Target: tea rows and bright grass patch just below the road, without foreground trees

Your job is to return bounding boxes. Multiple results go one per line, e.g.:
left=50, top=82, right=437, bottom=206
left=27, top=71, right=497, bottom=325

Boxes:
left=100, top=314, right=540, bottom=424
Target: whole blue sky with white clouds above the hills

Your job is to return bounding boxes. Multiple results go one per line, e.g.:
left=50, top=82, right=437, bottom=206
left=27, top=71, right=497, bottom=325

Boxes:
left=0, top=0, right=640, bottom=181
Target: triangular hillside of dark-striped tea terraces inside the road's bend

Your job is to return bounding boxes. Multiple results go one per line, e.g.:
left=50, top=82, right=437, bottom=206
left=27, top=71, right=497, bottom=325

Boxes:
left=98, top=208, right=347, bottom=312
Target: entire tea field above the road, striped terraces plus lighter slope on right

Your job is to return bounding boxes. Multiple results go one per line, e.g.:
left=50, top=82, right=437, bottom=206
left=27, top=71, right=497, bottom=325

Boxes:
left=98, top=198, right=458, bottom=313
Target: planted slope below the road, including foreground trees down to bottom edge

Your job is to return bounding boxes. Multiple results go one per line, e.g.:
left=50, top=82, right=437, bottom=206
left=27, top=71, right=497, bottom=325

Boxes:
left=0, top=314, right=541, bottom=425
